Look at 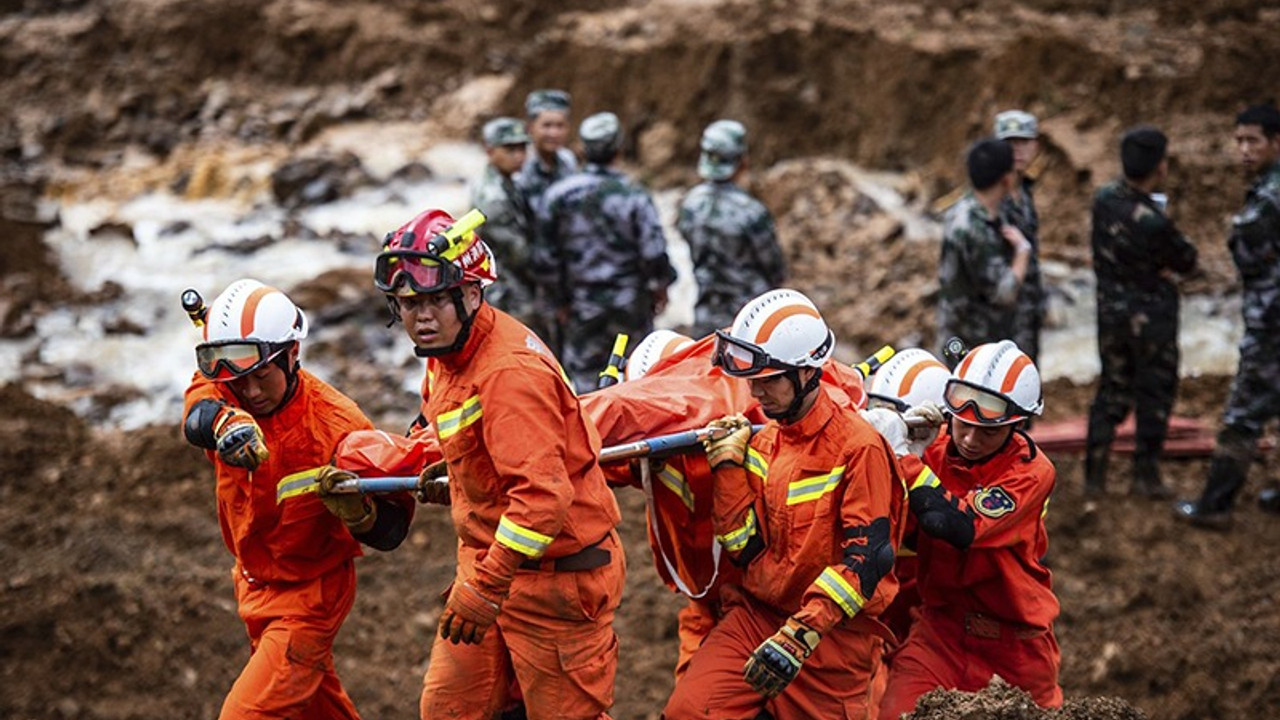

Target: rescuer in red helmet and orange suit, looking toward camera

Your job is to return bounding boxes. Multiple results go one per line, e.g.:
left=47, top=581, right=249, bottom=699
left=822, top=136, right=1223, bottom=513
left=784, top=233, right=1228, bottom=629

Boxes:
left=375, top=210, right=626, bottom=720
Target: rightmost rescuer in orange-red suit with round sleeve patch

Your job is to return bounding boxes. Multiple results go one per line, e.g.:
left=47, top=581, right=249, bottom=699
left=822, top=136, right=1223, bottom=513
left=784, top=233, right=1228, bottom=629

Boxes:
left=881, top=340, right=1062, bottom=720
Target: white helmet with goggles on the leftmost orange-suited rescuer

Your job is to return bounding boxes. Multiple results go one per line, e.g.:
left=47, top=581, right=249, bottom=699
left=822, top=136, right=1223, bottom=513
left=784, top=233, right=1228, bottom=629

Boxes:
left=196, top=279, right=307, bottom=380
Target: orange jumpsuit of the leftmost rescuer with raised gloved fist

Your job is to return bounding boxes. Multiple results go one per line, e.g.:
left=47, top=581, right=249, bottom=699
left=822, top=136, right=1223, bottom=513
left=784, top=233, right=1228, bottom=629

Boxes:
left=184, top=369, right=372, bottom=720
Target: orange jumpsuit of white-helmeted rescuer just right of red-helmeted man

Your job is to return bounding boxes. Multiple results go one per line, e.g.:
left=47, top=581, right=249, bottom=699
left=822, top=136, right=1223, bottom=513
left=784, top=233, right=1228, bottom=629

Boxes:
left=664, top=387, right=906, bottom=720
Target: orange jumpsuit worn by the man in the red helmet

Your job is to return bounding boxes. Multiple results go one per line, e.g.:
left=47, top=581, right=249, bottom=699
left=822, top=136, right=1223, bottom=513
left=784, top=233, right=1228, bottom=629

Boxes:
left=420, top=304, right=626, bottom=720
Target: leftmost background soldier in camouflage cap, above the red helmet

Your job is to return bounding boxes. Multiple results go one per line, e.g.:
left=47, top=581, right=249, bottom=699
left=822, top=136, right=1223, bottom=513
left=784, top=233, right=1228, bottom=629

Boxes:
left=471, top=118, right=547, bottom=327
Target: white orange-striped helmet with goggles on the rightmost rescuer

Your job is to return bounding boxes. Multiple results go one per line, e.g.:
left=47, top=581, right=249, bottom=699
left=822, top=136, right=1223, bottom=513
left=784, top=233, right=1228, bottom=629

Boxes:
left=943, top=340, right=1044, bottom=425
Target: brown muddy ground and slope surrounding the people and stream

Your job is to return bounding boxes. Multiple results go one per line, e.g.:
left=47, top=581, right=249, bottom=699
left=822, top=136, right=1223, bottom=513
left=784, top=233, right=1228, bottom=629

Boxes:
left=0, top=0, right=1280, bottom=720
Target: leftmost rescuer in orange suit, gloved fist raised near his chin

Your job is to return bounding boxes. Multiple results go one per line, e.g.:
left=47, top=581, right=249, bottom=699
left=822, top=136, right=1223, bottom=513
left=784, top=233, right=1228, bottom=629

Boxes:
left=183, top=279, right=413, bottom=720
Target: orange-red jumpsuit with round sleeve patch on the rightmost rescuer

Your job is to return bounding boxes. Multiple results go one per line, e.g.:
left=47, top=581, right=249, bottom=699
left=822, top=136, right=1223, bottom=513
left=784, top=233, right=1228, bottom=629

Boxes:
left=881, top=425, right=1062, bottom=719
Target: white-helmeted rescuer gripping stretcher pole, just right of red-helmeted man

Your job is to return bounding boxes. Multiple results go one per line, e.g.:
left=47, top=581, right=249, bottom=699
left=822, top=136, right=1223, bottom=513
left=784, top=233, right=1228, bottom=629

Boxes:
left=664, top=290, right=906, bottom=720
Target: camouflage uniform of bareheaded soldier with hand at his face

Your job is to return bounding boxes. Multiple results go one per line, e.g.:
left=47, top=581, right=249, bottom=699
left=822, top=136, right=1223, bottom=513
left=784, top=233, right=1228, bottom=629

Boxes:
left=938, top=191, right=1019, bottom=358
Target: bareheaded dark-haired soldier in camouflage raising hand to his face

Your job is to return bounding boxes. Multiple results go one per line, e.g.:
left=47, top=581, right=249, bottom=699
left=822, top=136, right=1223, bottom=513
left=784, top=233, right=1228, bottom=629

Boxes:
left=938, top=137, right=1032, bottom=355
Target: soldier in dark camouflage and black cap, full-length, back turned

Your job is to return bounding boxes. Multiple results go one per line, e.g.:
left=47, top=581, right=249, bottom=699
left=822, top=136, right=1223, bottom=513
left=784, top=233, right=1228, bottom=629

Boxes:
left=1084, top=127, right=1196, bottom=498
